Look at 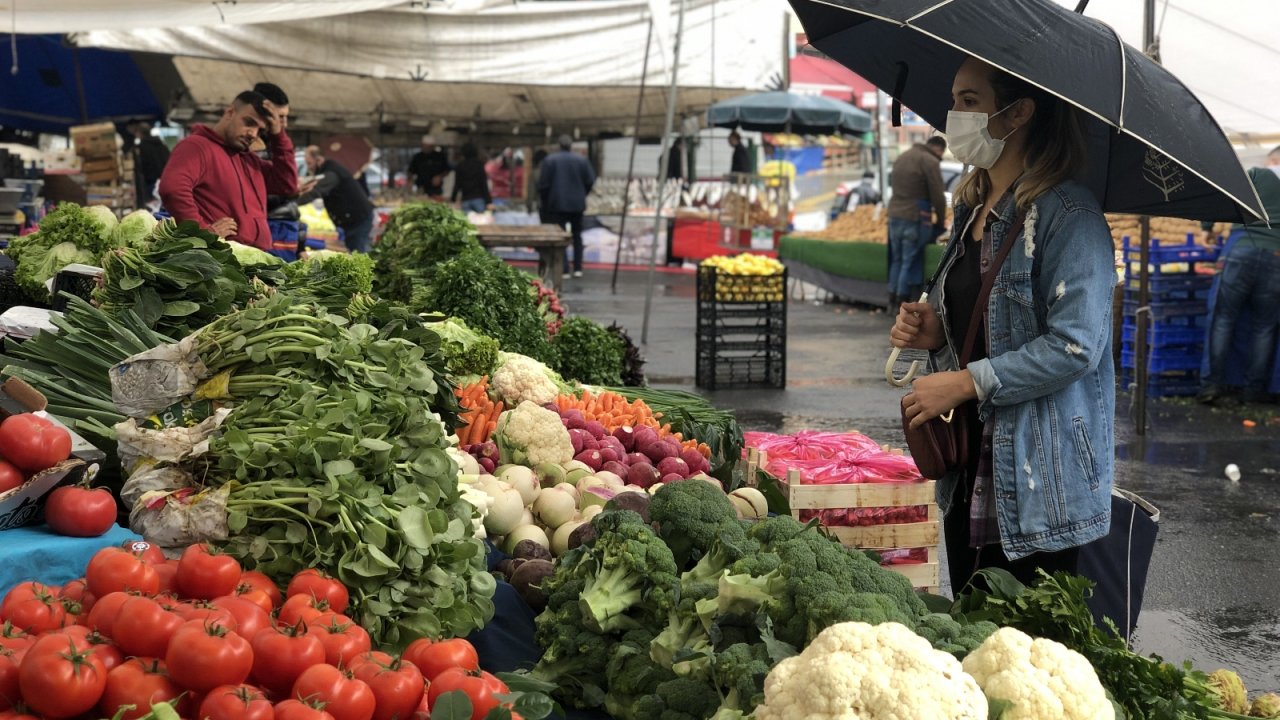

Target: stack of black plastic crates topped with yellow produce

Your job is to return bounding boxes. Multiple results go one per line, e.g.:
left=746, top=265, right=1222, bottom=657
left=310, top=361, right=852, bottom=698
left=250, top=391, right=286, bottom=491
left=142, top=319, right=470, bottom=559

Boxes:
left=695, top=265, right=787, bottom=389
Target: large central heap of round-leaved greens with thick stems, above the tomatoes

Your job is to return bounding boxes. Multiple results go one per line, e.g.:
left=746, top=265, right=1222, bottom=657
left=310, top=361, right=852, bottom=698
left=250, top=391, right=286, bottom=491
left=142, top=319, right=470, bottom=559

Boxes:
left=177, top=295, right=481, bottom=646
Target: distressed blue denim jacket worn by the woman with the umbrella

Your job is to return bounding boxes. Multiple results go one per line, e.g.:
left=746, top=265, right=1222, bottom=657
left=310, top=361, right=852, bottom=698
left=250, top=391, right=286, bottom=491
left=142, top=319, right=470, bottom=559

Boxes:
left=931, top=182, right=1116, bottom=560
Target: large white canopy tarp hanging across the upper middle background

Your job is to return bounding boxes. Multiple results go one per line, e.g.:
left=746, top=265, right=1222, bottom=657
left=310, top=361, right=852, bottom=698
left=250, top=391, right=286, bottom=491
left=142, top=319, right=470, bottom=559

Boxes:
left=73, top=0, right=786, bottom=132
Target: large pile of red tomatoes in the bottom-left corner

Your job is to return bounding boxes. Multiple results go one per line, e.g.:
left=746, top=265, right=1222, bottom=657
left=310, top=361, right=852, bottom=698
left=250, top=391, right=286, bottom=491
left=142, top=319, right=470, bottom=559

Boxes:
left=0, top=542, right=520, bottom=720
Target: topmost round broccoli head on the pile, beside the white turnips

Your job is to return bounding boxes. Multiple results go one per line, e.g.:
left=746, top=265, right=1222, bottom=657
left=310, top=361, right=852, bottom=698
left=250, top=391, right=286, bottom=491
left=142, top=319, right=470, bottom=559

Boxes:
left=649, top=480, right=741, bottom=570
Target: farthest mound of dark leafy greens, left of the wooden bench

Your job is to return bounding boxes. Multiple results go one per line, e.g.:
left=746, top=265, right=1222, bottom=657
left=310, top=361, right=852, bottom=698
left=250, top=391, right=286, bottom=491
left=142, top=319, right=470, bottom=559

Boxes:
left=374, top=202, right=486, bottom=302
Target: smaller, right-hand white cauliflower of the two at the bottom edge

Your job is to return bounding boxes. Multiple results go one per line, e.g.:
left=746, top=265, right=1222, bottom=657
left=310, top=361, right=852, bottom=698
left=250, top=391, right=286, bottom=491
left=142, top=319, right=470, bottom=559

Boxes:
left=964, top=628, right=1115, bottom=720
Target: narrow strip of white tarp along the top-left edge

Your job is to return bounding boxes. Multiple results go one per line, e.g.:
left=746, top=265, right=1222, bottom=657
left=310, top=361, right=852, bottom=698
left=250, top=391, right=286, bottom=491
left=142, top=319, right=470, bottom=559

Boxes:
left=0, top=0, right=403, bottom=35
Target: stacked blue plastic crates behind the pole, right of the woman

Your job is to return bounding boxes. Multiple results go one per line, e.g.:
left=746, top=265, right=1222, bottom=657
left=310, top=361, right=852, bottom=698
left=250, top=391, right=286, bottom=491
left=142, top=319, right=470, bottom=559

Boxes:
left=1120, top=234, right=1219, bottom=397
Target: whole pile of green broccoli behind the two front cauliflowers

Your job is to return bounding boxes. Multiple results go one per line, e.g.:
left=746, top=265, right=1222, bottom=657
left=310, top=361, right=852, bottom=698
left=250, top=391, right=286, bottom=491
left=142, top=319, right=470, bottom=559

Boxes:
left=534, top=480, right=996, bottom=720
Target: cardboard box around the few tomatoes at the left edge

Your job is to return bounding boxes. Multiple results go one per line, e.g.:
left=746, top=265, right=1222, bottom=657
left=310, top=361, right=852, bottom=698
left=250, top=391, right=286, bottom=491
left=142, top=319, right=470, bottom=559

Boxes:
left=0, top=378, right=106, bottom=530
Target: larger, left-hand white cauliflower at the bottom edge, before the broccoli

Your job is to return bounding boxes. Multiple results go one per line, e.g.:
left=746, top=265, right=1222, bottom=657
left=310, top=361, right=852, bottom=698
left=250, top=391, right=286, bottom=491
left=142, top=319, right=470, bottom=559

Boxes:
left=755, top=623, right=987, bottom=720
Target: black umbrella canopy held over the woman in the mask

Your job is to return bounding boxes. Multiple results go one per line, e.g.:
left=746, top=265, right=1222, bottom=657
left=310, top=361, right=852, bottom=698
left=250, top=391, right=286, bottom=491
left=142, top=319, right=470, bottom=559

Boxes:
left=791, top=0, right=1265, bottom=222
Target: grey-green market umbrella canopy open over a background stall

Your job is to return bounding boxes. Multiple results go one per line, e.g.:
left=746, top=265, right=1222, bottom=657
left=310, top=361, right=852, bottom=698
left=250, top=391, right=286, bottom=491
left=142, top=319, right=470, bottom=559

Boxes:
left=707, top=90, right=872, bottom=135
